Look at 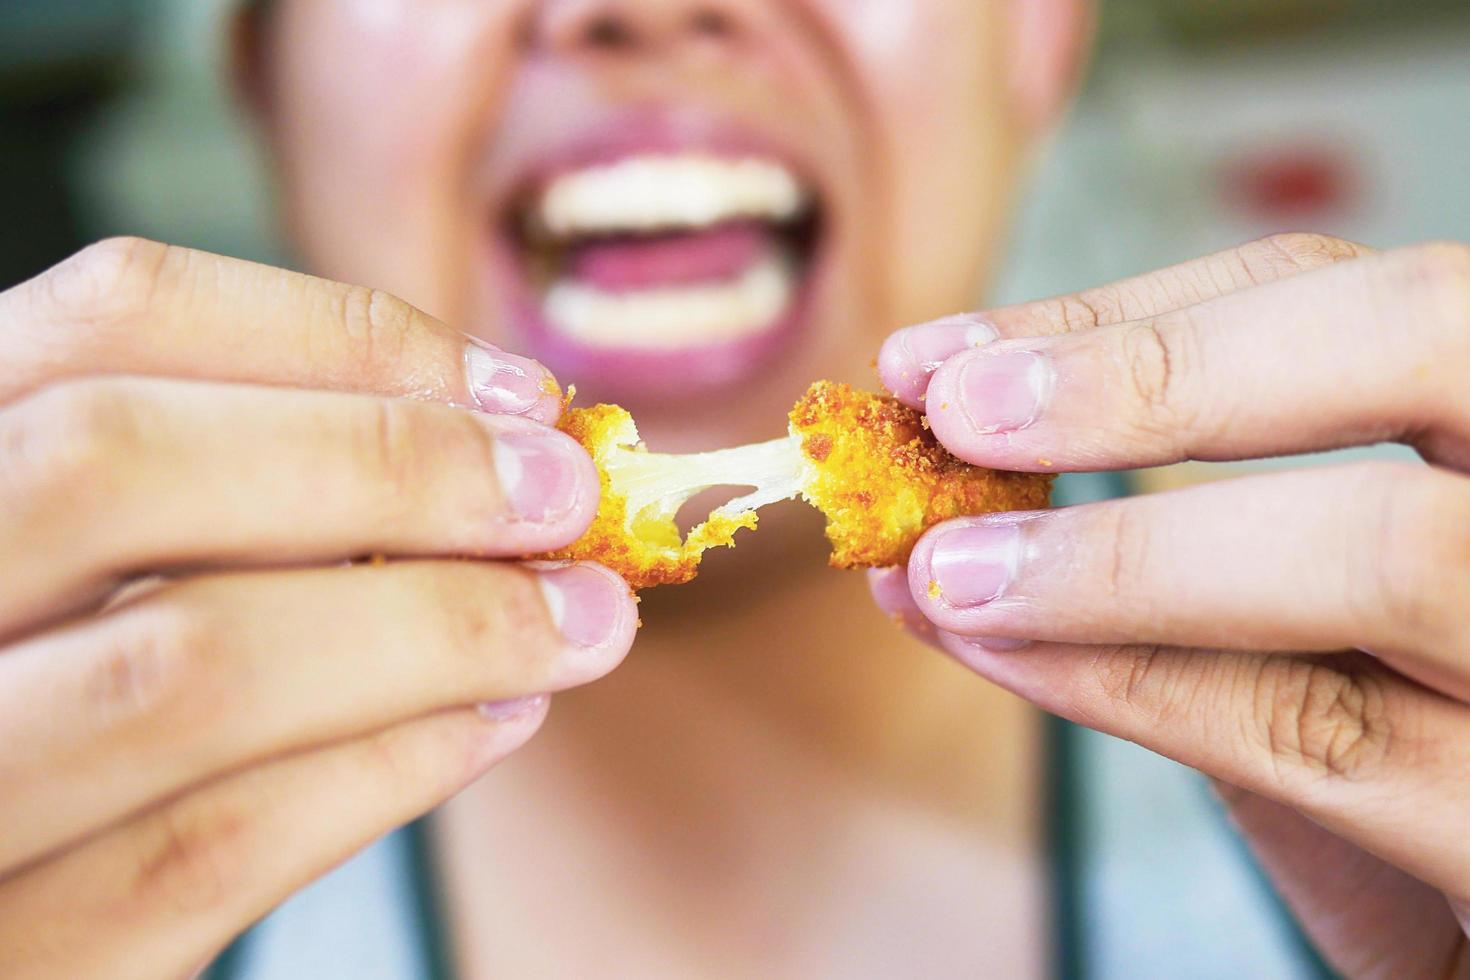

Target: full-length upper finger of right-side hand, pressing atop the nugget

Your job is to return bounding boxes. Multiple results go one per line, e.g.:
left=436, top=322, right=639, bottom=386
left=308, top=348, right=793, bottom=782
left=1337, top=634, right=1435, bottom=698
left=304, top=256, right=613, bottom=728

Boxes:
left=926, top=245, right=1470, bottom=470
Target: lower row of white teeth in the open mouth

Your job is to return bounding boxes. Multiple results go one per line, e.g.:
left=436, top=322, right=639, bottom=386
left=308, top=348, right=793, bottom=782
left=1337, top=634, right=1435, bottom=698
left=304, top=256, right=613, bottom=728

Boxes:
left=542, top=257, right=795, bottom=350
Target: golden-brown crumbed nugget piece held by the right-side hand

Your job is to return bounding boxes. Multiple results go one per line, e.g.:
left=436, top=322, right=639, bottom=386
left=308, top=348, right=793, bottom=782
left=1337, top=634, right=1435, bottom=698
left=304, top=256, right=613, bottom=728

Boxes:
left=791, top=381, right=1053, bottom=569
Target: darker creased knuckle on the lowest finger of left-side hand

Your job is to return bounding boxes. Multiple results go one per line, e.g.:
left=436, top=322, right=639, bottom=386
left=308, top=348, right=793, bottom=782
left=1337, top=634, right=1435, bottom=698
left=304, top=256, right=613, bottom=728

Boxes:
left=134, top=792, right=251, bottom=915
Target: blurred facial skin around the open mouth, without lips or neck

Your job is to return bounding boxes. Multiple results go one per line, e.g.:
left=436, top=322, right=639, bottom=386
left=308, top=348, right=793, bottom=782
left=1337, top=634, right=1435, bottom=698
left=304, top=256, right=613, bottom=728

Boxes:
left=247, top=0, right=1058, bottom=451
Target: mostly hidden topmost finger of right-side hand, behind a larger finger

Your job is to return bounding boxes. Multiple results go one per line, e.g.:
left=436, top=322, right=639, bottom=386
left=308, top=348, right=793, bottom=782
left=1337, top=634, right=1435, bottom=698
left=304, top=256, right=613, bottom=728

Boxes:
left=878, top=234, right=1370, bottom=408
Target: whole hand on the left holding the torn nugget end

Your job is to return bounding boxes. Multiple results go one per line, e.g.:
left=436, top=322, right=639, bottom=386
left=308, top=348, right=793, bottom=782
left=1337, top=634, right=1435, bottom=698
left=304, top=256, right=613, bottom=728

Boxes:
left=0, top=239, right=637, bottom=977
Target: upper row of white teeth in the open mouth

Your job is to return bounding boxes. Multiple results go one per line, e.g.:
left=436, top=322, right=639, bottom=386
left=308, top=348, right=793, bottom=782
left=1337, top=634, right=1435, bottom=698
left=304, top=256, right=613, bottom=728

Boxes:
left=537, top=154, right=806, bottom=235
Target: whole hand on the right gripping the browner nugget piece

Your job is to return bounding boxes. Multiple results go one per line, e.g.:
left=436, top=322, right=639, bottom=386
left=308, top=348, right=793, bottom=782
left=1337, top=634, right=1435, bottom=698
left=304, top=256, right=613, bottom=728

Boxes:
left=872, top=235, right=1470, bottom=977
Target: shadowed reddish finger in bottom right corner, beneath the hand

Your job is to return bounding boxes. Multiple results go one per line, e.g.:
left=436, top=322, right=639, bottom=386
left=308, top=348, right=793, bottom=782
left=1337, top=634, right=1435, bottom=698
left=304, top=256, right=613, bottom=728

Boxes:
left=1222, top=788, right=1470, bottom=979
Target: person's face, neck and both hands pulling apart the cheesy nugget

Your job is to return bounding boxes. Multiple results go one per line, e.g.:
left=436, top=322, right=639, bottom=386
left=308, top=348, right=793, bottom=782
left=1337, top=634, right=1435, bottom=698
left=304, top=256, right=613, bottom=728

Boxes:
left=0, top=0, right=1470, bottom=977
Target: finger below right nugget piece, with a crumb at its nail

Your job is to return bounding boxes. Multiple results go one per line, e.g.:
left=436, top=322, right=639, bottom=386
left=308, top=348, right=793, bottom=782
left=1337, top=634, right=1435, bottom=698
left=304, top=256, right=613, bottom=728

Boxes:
left=908, top=463, right=1470, bottom=698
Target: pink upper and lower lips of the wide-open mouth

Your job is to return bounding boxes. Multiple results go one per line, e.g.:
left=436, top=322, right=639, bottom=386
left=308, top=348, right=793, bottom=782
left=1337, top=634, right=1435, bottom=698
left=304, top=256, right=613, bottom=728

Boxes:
left=490, top=109, right=826, bottom=404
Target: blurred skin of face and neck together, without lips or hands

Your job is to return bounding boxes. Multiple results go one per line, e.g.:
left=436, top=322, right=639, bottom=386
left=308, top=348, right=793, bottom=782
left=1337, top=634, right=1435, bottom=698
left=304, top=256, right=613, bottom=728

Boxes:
left=246, top=0, right=1085, bottom=976
